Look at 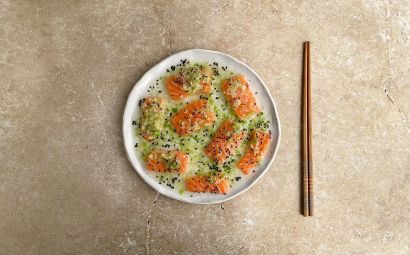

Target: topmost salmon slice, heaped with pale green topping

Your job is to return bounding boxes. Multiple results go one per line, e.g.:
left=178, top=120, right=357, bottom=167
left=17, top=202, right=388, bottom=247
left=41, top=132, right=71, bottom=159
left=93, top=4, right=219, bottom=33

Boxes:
left=165, top=65, right=212, bottom=100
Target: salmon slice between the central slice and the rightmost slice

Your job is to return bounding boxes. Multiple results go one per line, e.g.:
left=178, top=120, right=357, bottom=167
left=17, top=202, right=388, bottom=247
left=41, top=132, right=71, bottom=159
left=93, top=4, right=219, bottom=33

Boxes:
left=205, top=120, right=244, bottom=164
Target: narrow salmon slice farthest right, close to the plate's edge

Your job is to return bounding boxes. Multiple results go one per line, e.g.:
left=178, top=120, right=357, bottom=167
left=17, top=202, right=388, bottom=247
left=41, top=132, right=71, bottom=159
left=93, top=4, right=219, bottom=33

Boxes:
left=237, top=130, right=272, bottom=174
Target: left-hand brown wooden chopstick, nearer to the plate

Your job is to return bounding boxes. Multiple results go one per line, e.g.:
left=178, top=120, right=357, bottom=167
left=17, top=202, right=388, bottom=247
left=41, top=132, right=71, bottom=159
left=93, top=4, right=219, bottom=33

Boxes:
left=302, top=42, right=309, bottom=217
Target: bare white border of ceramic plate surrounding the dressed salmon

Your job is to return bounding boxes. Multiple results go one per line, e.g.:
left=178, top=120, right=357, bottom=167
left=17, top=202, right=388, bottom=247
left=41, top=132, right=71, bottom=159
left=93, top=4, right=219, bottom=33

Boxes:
left=123, top=49, right=280, bottom=204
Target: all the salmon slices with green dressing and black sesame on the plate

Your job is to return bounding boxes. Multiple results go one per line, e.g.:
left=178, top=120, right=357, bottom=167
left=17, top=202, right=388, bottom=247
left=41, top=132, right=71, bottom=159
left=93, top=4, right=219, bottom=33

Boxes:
left=132, top=60, right=271, bottom=196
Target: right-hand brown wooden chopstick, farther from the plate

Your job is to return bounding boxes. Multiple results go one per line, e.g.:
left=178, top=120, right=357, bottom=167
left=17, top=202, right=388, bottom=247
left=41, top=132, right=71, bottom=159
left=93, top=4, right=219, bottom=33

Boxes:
left=306, top=42, right=313, bottom=216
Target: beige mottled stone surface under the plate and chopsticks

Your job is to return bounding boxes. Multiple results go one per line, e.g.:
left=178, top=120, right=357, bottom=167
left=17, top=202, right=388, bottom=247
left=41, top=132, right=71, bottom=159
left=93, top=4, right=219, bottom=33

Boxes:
left=0, top=0, right=410, bottom=255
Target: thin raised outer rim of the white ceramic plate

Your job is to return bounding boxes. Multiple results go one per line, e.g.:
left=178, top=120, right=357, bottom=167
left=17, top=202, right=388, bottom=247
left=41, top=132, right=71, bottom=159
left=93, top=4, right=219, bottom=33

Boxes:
left=122, top=48, right=282, bottom=205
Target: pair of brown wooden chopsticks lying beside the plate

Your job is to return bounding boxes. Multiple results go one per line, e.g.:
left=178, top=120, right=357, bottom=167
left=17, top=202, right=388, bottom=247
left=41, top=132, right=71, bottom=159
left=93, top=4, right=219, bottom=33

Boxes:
left=302, top=42, right=313, bottom=217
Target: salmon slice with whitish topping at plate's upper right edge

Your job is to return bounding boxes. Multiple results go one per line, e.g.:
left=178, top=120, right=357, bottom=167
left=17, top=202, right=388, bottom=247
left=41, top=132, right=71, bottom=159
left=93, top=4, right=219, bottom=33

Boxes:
left=221, top=75, right=260, bottom=118
